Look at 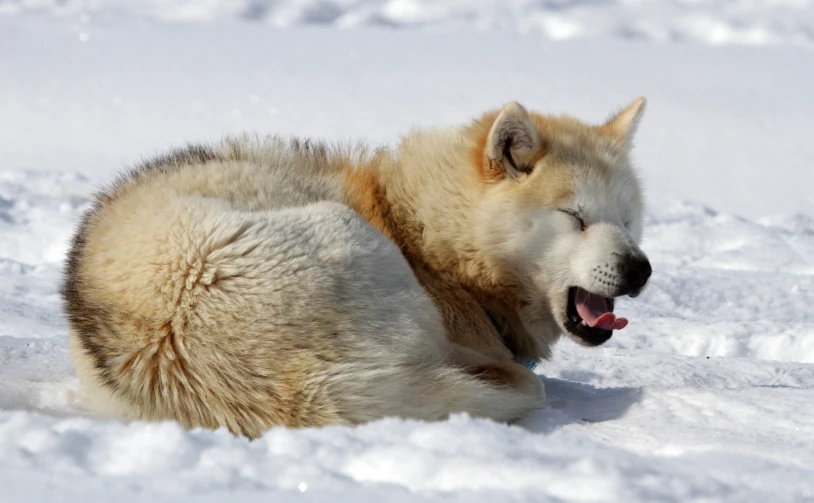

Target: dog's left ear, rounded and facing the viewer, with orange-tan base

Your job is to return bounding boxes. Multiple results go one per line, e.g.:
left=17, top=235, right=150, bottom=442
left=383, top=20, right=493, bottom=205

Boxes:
left=486, top=101, right=541, bottom=178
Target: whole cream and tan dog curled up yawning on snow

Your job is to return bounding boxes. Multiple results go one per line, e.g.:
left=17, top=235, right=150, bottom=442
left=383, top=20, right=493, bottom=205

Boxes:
left=62, top=98, right=651, bottom=438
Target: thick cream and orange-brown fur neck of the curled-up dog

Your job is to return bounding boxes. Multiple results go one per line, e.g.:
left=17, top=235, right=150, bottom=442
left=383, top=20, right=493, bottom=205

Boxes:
left=348, top=130, right=538, bottom=358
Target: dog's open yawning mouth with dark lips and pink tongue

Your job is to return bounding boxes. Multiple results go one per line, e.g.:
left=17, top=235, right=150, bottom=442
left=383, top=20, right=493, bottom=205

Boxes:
left=565, top=286, right=627, bottom=346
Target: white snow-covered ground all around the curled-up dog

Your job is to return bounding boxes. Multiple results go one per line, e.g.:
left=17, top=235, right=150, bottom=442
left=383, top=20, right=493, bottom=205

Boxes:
left=0, top=0, right=814, bottom=503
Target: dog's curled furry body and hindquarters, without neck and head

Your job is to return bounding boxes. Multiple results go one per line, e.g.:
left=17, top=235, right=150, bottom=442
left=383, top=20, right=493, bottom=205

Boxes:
left=63, top=138, right=542, bottom=437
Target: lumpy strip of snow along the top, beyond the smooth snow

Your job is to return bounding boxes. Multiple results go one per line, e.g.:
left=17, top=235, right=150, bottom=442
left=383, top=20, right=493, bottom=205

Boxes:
left=0, top=0, right=814, bottom=47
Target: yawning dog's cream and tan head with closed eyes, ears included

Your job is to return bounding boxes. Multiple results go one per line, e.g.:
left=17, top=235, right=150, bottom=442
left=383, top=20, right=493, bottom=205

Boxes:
left=473, top=98, right=651, bottom=346
